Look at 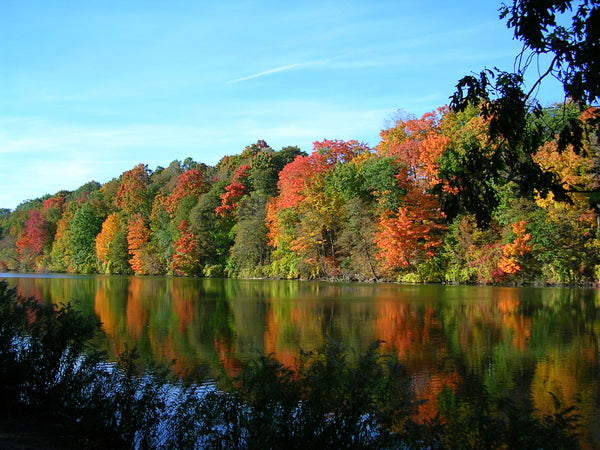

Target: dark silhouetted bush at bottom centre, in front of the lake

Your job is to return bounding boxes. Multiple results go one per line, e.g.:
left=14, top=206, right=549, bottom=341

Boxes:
left=219, top=341, right=414, bottom=449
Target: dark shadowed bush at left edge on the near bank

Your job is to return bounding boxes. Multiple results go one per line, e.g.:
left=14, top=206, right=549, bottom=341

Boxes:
left=0, top=281, right=99, bottom=418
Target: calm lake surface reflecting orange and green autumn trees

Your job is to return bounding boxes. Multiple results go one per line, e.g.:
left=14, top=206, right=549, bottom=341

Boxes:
left=0, top=274, right=600, bottom=447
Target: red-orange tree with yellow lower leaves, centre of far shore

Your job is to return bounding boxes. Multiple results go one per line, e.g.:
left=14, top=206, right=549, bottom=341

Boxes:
left=266, top=140, right=370, bottom=277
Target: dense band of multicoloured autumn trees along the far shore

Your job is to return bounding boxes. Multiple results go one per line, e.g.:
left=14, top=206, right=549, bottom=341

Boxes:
left=0, top=102, right=600, bottom=284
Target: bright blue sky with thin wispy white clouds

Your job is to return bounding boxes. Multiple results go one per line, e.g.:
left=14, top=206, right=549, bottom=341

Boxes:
left=0, top=0, right=561, bottom=209
